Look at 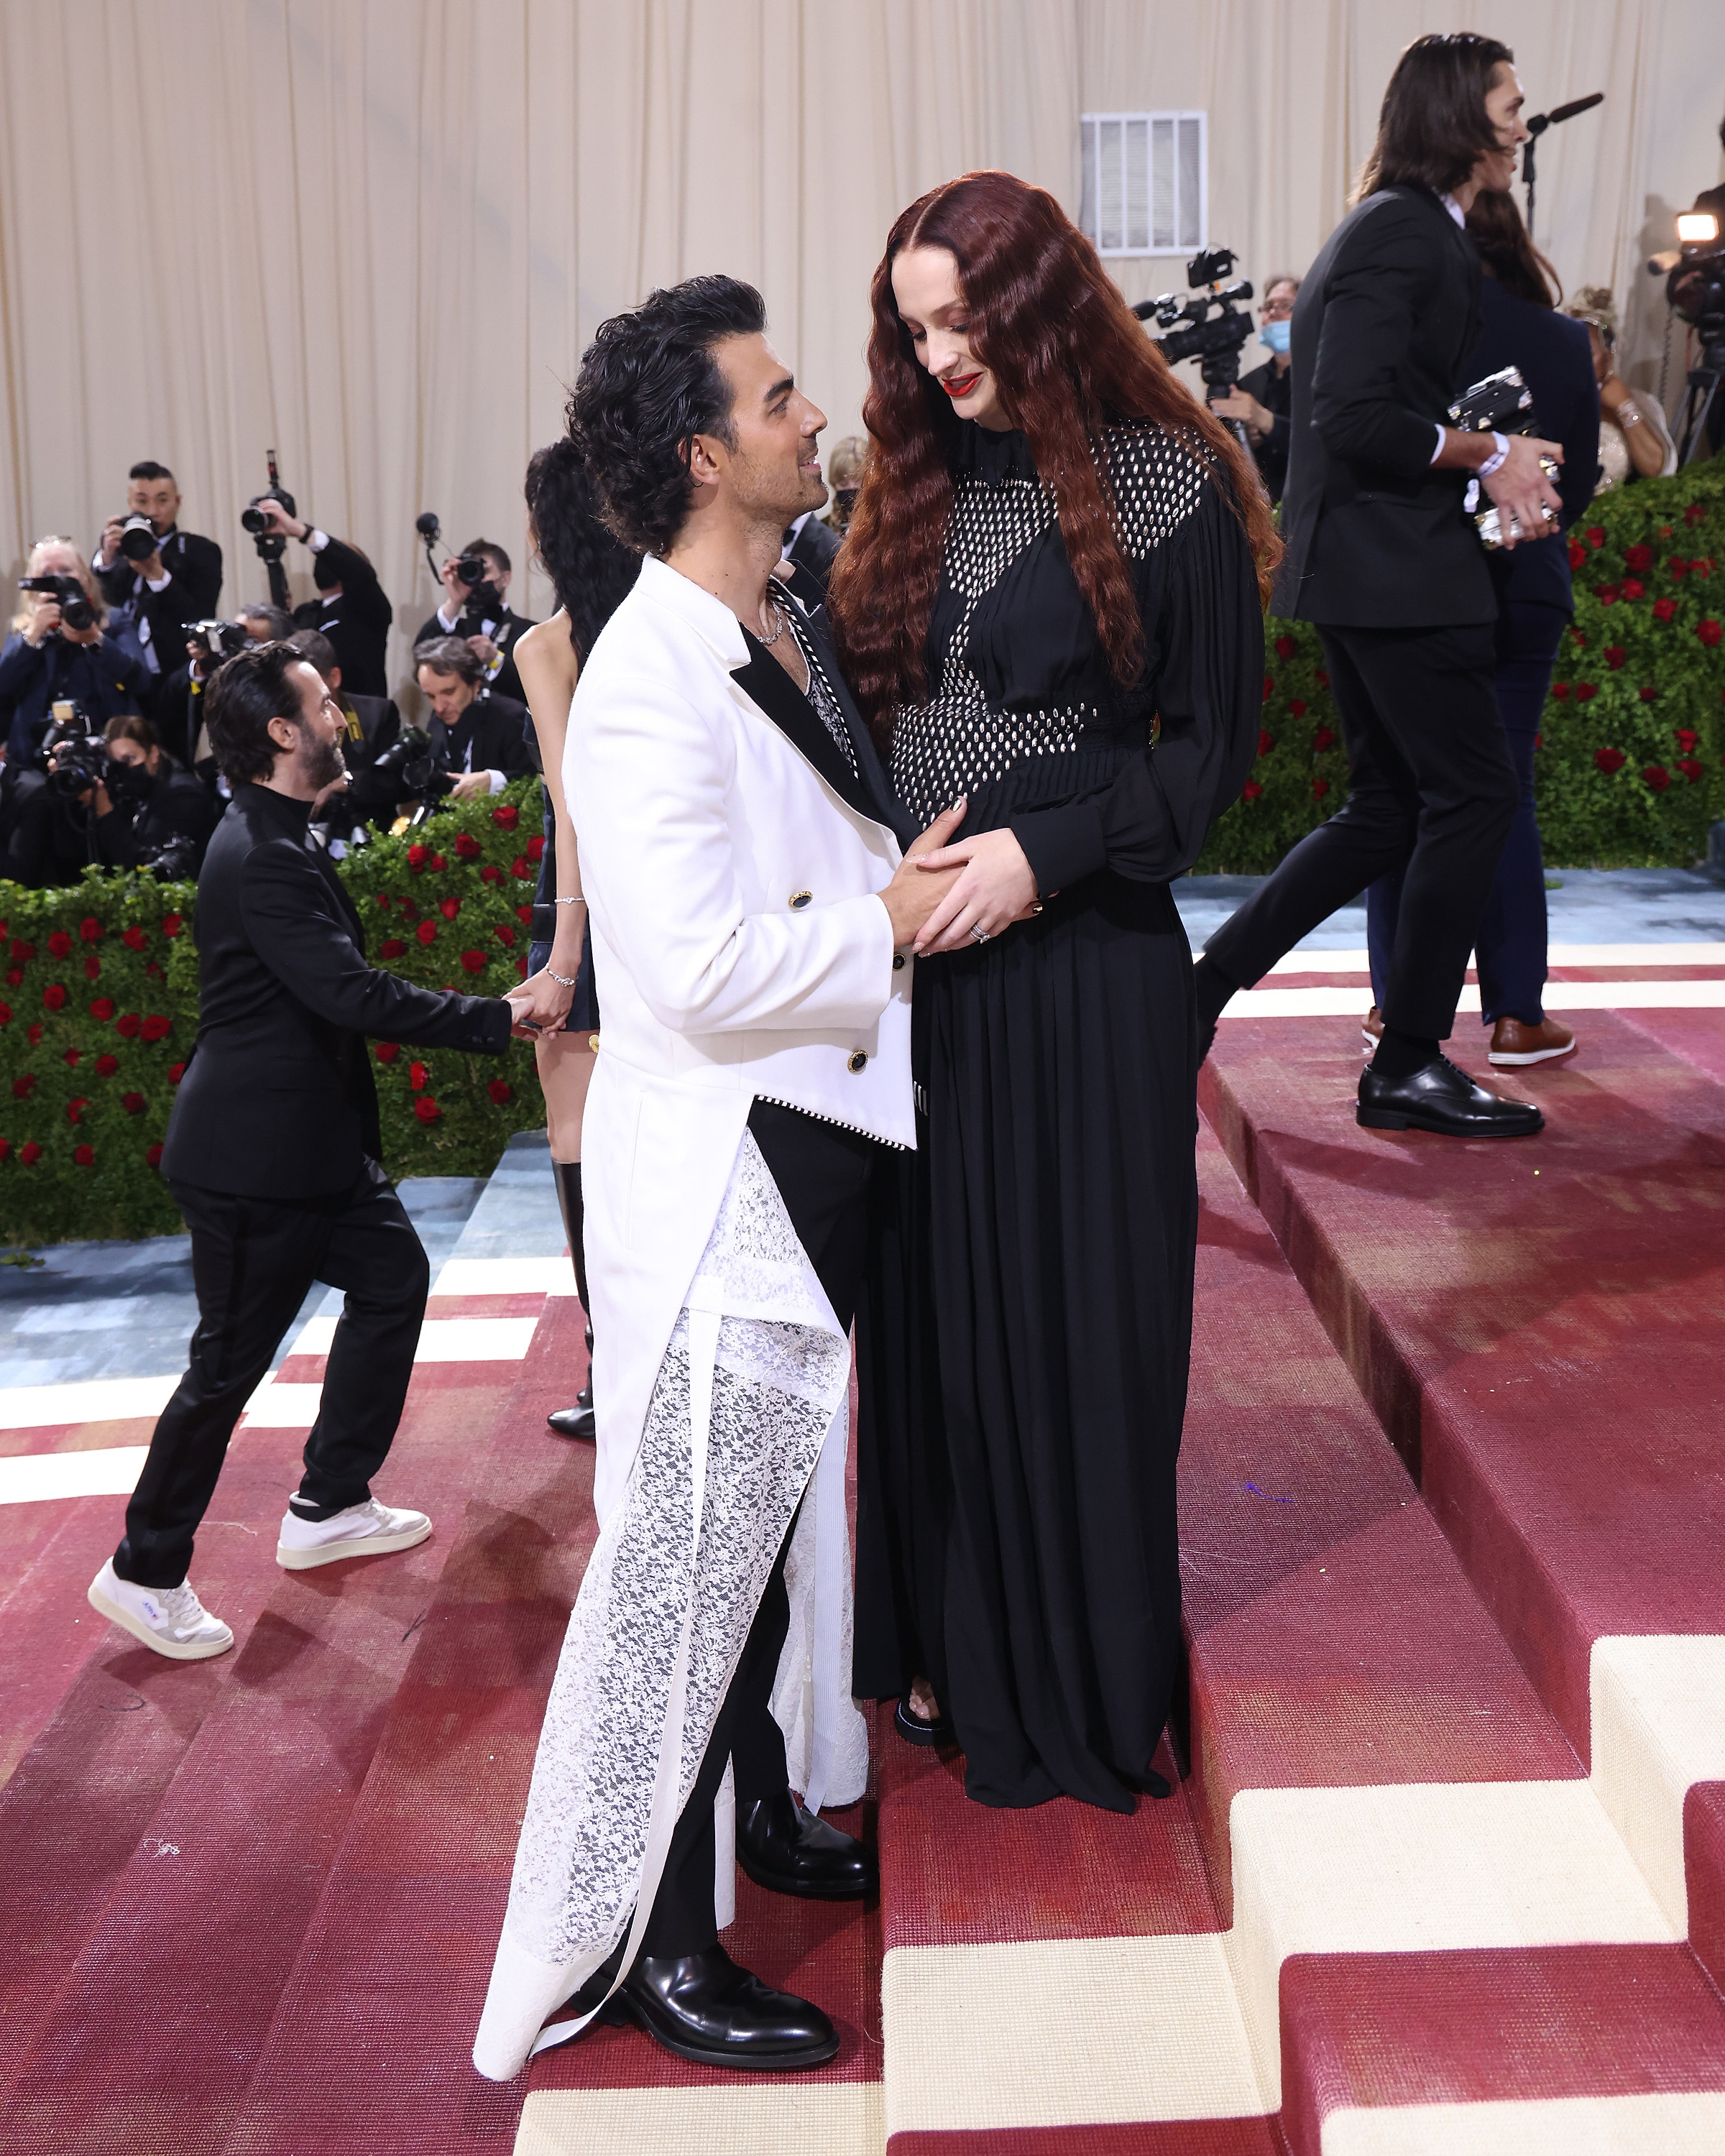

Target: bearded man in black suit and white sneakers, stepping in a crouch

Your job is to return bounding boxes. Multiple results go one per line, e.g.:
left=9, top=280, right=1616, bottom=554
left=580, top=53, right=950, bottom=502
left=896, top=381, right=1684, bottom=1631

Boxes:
left=91, top=645, right=533, bottom=1662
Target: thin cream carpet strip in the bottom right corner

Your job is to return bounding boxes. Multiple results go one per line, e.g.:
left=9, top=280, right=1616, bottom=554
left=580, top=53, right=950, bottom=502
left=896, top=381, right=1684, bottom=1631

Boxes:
left=1320, top=2093, right=1725, bottom=2156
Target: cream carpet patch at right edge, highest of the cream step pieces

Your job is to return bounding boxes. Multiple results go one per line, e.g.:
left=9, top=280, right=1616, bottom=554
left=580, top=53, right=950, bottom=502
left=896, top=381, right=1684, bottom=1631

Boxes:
left=1589, top=1634, right=1725, bottom=1932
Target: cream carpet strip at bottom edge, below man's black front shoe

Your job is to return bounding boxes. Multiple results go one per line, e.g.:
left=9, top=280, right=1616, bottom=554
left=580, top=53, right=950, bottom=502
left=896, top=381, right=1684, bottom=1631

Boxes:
left=515, top=2078, right=886, bottom=2156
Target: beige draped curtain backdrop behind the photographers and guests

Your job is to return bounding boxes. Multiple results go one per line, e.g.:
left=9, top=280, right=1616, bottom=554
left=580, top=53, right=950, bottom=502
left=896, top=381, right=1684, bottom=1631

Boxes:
left=0, top=0, right=1725, bottom=679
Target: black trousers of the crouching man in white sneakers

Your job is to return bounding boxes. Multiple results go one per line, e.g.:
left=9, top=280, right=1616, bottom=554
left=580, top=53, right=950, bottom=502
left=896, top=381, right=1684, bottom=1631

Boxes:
left=114, top=1162, right=431, bottom=1587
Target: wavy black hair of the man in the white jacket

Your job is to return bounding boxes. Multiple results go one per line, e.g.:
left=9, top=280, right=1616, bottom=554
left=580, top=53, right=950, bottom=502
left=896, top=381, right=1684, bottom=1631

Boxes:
left=569, top=276, right=768, bottom=554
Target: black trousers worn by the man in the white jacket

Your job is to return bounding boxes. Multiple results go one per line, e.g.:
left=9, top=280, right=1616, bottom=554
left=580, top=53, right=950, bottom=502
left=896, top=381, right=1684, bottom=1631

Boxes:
left=640, top=1100, right=878, bottom=1955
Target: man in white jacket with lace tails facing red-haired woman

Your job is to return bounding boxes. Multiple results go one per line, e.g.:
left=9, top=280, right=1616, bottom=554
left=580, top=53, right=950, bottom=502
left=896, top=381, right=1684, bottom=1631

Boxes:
left=474, top=278, right=962, bottom=2078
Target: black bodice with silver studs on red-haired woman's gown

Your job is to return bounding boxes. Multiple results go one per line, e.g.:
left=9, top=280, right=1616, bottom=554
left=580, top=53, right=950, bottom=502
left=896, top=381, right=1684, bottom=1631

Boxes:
left=893, top=425, right=1208, bottom=824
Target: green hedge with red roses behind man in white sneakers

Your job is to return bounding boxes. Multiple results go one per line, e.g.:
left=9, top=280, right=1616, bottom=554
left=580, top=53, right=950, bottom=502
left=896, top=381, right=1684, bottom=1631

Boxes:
left=0, top=778, right=546, bottom=1244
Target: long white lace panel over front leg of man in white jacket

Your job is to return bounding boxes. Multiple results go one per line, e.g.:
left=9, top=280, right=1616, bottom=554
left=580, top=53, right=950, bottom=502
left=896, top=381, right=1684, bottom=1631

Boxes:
left=477, top=1134, right=850, bottom=2076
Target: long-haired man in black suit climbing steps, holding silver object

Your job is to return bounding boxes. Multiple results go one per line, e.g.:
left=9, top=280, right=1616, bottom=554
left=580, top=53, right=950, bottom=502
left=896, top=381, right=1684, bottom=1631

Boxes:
left=1195, top=34, right=1563, bottom=1138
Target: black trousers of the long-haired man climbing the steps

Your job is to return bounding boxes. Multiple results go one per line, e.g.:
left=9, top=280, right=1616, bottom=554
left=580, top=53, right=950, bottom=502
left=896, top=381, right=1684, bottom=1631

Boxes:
left=1203, top=621, right=1518, bottom=1041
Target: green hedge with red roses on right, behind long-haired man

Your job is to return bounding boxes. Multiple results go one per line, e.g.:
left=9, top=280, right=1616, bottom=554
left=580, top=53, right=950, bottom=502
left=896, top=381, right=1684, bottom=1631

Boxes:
left=1199, top=459, right=1725, bottom=875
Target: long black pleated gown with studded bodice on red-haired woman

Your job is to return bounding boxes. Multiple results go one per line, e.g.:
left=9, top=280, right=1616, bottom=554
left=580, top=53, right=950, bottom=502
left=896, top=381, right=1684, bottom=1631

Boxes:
left=854, top=412, right=1264, bottom=1811
